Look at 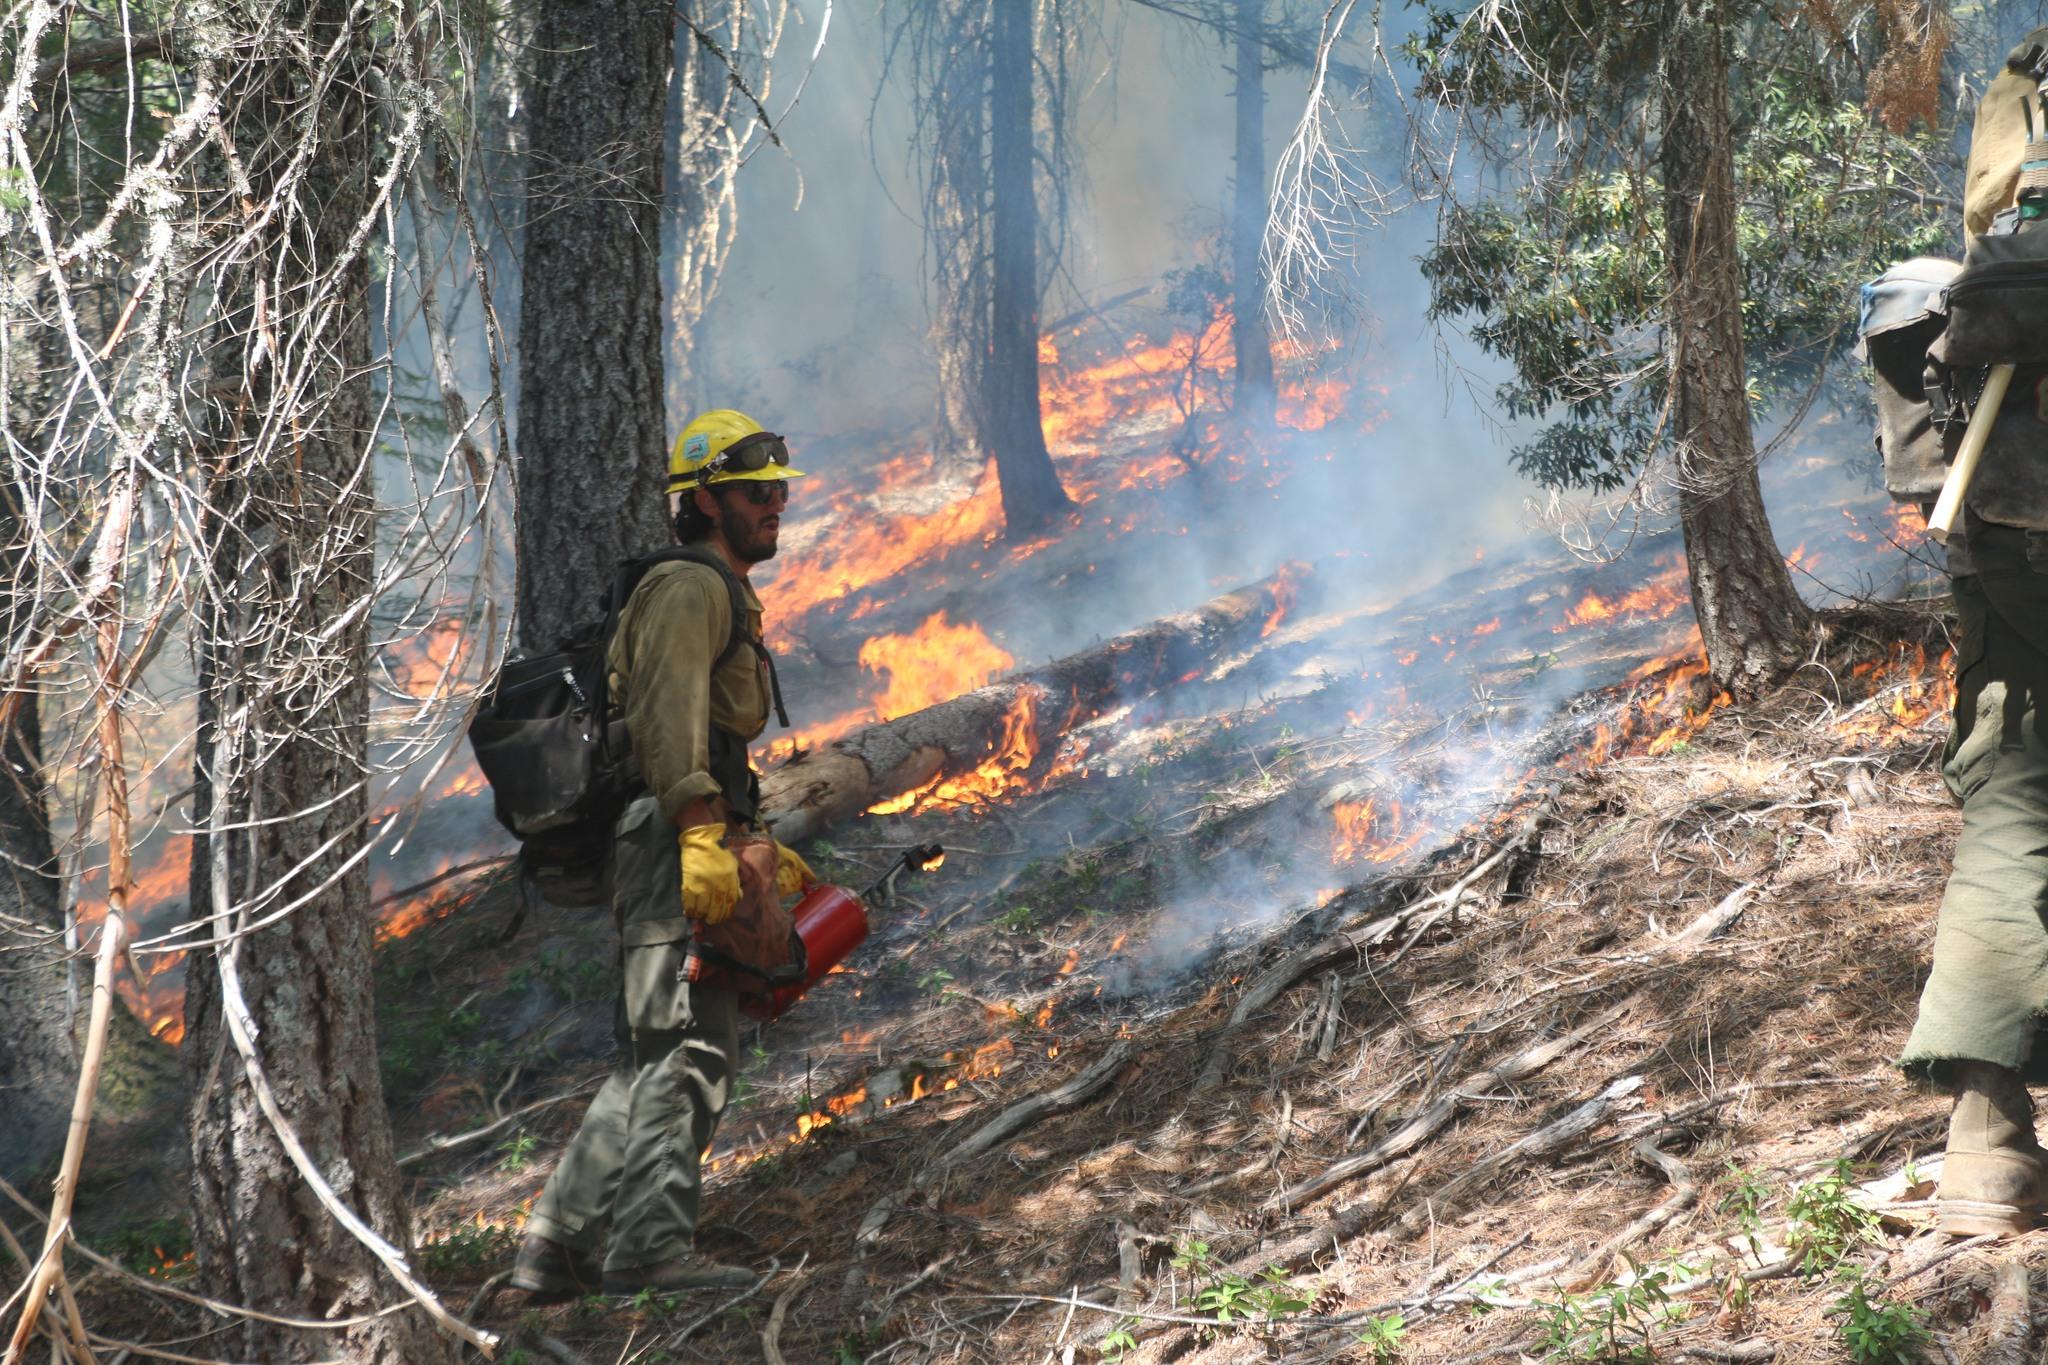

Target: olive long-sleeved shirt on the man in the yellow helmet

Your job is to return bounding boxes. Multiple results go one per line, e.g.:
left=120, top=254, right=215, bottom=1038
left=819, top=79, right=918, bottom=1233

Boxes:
left=606, top=561, right=770, bottom=821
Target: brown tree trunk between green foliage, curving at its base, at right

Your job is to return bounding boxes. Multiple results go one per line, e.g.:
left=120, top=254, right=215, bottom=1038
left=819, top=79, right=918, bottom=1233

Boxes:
left=1659, top=0, right=1812, bottom=692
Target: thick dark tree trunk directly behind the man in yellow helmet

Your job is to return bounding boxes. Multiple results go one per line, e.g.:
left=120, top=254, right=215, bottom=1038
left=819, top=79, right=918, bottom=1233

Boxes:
left=518, top=0, right=674, bottom=649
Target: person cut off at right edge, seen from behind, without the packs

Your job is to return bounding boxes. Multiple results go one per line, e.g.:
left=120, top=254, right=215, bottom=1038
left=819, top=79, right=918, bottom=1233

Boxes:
left=1880, top=29, right=2048, bottom=1236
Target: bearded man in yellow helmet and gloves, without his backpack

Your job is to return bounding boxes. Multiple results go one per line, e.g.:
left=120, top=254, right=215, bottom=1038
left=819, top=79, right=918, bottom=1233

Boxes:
left=512, top=409, right=815, bottom=1302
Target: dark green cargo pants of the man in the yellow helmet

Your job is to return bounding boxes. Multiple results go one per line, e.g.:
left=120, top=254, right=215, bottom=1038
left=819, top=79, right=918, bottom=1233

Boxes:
left=526, top=798, right=739, bottom=1271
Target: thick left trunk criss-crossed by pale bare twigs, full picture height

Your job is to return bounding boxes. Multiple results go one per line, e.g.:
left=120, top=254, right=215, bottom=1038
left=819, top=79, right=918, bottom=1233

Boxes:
left=184, top=0, right=457, bottom=1365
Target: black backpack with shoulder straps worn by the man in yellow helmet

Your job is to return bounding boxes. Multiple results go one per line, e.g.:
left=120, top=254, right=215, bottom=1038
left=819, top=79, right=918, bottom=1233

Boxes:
left=469, top=546, right=788, bottom=907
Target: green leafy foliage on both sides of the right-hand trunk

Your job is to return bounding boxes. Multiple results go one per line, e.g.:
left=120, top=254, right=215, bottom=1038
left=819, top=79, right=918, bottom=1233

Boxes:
left=1409, top=0, right=1960, bottom=491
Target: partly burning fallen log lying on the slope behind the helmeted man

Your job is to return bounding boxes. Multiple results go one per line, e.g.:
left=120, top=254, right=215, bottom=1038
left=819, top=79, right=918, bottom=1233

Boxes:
left=762, top=567, right=1300, bottom=843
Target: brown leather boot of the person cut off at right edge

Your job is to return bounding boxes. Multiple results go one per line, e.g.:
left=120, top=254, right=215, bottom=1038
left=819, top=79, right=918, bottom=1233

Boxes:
left=1935, top=1062, right=2048, bottom=1236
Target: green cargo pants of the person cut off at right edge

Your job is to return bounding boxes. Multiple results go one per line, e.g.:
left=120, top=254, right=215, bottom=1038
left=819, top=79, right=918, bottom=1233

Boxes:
left=1903, top=520, right=2048, bottom=1085
